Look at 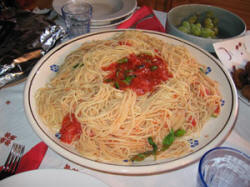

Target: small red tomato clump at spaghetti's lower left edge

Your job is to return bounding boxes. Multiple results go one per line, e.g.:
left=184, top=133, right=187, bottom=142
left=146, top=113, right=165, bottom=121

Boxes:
left=60, top=114, right=82, bottom=144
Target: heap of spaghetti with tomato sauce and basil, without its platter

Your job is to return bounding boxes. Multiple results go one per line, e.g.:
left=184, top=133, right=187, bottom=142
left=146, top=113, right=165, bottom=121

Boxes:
left=36, top=31, right=221, bottom=163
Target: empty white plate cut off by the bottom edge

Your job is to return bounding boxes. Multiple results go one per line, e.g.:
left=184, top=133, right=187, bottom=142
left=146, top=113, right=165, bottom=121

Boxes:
left=0, top=169, right=108, bottom=187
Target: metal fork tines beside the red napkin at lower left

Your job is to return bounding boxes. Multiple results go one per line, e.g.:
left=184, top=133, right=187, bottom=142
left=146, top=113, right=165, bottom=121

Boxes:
left=0, top=143, right=25, bottom=180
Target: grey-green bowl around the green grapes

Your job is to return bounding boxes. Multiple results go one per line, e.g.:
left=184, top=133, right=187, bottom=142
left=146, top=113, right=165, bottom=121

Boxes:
left=167, top=4, right=246, bottom=53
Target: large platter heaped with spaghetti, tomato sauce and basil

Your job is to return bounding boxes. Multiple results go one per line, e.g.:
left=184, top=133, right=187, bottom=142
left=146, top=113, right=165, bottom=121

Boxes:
left=24, top=30, right=238, bottom=175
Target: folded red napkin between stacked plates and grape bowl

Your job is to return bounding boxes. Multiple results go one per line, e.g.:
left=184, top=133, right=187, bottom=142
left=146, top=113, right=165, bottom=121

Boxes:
left=117, top=6, right=165, bottom=32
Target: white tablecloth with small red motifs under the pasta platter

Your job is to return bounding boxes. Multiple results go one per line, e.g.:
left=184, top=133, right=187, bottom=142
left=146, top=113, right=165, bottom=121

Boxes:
left=0, top=12, right=250, bottom=187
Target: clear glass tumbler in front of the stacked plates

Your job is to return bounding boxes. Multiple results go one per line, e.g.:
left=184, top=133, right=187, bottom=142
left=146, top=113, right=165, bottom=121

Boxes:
left=61, top=1, right=92, bottom=38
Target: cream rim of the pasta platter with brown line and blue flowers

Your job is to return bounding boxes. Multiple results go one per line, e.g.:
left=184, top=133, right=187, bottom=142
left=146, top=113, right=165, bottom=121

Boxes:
left=24, top=30, right=238, bottom=175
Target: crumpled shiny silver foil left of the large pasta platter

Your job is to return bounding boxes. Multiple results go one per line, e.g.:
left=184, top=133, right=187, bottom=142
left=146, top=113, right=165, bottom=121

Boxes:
left=0, top=9, right=66, bottom=88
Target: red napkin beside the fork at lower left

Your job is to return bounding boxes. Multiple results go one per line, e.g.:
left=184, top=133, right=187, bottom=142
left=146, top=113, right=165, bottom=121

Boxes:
left=16, top=142, right=48, bottom=173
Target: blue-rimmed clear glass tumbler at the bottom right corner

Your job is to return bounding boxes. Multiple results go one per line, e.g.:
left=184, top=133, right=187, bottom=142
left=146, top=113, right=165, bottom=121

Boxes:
left=197, top=147, right=250, bottom=187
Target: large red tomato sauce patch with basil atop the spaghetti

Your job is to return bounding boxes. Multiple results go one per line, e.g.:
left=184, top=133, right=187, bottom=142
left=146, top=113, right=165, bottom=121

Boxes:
left=102, top=54, right=173, bottom=96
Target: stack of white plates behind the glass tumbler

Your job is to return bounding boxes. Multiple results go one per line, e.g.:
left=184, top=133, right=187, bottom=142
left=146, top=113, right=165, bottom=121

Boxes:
left=53, top=0, right=137, bottom=32
